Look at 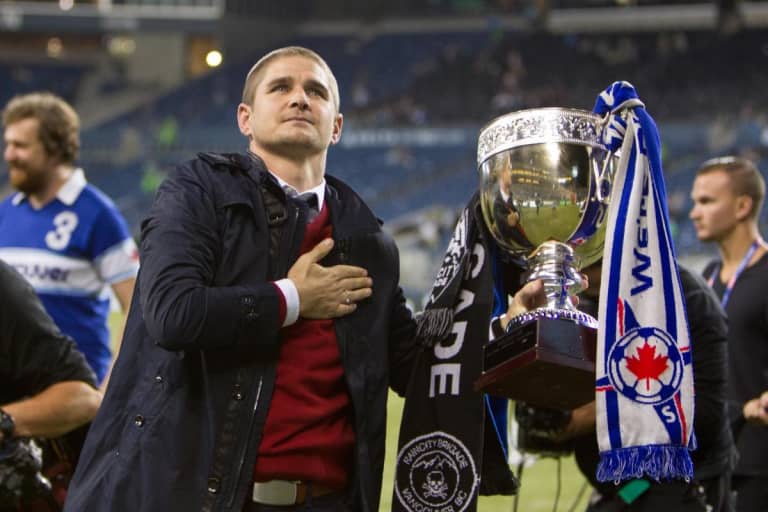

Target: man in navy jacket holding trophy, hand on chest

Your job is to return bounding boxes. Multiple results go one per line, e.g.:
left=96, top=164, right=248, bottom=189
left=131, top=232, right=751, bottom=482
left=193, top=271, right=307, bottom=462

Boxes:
left=66, top=47, right=540, bottom=512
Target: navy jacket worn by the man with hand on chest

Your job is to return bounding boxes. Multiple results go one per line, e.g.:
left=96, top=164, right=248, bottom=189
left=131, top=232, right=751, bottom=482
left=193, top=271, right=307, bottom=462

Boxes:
left=65, top=154, right=416, bottom=512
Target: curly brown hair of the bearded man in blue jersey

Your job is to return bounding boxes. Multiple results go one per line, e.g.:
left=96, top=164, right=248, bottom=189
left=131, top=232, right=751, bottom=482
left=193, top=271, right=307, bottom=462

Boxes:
left=3, top=92, right=80, bottom=164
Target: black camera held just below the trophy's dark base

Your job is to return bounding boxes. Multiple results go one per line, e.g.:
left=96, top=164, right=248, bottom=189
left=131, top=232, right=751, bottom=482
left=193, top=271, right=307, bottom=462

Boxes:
left=515, top=402, right=573, bottom=457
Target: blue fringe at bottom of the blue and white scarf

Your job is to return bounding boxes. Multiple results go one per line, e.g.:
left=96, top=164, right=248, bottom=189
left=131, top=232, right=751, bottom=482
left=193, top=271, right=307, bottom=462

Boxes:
left=597, top=445, right=693, bottom=484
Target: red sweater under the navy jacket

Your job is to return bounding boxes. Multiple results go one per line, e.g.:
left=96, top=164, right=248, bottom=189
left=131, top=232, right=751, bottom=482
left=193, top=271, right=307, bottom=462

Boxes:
left=254, top=205, right=355, bottom=489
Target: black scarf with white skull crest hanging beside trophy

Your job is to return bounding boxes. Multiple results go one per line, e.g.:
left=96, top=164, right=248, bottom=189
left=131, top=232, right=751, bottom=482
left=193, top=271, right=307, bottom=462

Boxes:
left=392, top=194, right=517, bottom=512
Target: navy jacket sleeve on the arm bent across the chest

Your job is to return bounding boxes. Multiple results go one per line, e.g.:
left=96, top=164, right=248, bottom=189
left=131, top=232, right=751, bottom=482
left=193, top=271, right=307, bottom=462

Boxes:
left=138, top=160, right=280, bottom=350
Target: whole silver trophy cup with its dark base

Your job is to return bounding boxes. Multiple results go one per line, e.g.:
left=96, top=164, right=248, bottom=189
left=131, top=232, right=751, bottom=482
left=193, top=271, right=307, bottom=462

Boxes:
left=468, top=108, right=611, bottom=409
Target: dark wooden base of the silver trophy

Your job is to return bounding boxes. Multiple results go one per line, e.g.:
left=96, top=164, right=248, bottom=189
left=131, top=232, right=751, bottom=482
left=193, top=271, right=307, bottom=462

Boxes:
left=475, top=318, right=597, bottom=409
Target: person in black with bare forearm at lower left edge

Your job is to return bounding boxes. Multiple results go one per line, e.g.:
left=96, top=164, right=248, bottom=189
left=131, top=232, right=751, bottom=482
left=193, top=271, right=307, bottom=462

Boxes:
left=0, top=262, right=101, bottom=510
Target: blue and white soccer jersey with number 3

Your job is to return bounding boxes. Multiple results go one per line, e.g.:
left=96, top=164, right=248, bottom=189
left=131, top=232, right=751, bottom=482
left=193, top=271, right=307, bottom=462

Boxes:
left=0, top=169, right=139, bottom=382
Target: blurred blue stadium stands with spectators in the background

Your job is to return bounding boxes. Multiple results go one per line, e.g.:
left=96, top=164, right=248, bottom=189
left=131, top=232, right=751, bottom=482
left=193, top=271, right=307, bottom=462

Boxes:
left=0, top=25, right=768, bottom=296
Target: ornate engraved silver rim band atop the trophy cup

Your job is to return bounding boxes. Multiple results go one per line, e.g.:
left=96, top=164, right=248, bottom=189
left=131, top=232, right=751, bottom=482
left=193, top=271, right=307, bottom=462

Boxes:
left=477, top=107, right=603, bottom=166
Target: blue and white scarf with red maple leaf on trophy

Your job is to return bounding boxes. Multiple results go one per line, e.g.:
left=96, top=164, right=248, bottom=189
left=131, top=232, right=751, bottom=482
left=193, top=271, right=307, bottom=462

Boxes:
left=593, top=82, right=695, bottom=482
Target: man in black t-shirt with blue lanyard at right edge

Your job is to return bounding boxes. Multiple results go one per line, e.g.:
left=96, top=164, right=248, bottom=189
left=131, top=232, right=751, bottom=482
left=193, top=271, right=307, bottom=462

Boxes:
left=690, top=157, right=768, bottom=512
